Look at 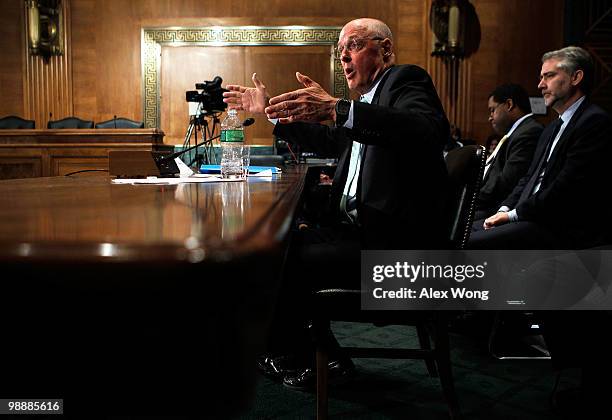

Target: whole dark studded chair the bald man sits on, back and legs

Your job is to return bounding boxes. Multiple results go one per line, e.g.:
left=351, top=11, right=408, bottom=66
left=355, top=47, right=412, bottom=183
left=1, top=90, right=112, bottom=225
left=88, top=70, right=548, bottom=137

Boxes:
left=312, top=145, right=486, bottom=419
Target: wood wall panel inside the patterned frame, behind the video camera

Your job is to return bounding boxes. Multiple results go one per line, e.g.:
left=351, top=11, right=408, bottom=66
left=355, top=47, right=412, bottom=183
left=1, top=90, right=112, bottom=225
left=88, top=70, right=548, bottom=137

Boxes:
left=160, top=45, right=331, bottom=144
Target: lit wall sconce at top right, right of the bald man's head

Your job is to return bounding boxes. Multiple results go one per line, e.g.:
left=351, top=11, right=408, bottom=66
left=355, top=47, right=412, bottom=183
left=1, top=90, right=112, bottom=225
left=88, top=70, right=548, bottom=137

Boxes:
left=429, top=0, right=469, bottom=60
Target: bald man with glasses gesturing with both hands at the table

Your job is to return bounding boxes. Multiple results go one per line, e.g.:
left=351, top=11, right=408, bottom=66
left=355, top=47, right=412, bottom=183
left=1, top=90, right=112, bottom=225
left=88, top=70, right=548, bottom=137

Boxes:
left=224, top=18, right=449, bottom=389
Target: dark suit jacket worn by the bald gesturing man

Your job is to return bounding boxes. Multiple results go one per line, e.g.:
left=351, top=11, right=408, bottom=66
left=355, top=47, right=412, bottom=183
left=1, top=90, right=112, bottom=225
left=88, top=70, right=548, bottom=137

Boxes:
left=274, top=65, right=449, bottom=249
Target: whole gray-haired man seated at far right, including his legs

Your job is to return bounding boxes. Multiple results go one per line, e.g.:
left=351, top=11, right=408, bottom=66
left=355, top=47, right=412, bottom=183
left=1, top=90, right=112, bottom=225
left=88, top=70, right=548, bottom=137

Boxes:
left=468, top=47, right=612, bottom=418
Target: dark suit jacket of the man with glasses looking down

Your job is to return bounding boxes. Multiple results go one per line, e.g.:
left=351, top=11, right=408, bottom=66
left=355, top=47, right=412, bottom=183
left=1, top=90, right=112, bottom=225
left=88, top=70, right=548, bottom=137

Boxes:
left=476, top=117, right=544, bottom=216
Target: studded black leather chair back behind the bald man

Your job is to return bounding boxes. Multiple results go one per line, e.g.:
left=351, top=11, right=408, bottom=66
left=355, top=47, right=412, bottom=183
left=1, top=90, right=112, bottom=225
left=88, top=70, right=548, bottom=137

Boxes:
left=446, top=145, right=487, bottom=249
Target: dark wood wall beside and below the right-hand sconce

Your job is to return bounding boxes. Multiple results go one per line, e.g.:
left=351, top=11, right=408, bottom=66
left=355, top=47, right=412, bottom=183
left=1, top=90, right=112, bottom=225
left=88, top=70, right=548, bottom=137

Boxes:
left=436, top=0, right=563, bottom=143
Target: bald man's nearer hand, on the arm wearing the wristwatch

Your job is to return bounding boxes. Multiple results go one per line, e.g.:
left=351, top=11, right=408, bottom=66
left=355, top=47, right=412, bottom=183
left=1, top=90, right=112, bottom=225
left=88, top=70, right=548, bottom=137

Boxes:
left=265, top=72, right=338, bottom=123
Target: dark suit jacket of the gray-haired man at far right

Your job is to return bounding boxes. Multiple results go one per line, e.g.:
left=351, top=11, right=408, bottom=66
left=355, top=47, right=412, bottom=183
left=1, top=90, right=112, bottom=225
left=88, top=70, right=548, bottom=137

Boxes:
left=502, top=99, right=612, bottom=248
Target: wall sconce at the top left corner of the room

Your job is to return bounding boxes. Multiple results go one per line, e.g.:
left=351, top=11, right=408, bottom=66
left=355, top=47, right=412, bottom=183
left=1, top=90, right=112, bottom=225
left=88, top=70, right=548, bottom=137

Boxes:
left=25, top=0, right=63, bottom=61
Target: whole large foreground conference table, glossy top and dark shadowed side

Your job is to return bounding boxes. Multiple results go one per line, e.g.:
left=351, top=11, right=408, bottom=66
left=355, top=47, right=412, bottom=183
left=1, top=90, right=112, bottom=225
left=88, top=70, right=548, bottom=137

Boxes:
left=0, top=167, right=306, bottom=418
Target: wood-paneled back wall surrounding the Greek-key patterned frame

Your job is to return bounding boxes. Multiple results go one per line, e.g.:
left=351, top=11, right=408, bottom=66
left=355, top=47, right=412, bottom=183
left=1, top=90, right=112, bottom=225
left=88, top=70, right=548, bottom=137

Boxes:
left=0, top=0, right=563, bottom=142
